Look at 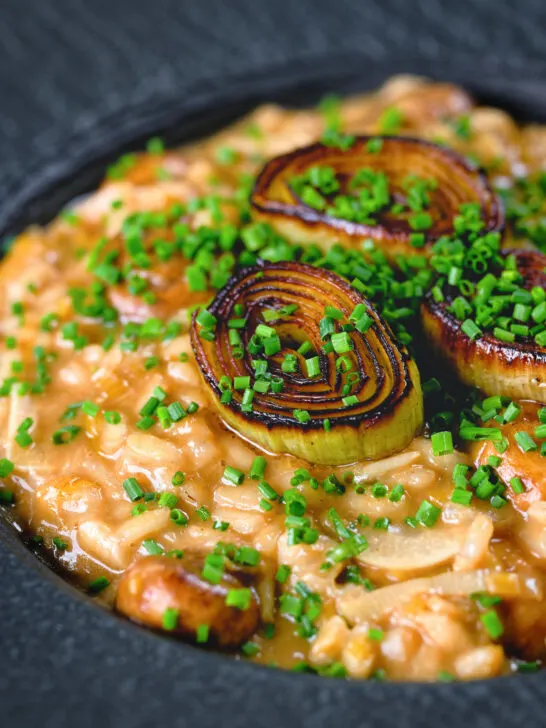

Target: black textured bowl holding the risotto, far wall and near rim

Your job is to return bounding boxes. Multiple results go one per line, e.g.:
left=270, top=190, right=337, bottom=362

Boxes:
left=0, top=49, right=546, bottom=728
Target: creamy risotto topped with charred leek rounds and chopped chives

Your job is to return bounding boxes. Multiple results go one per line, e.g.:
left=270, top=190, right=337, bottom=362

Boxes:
left=0, top=76, right=546, bottom=681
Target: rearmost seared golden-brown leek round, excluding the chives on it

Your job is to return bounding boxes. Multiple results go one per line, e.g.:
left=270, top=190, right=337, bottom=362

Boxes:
left=251, top=136, right=504, bottom=260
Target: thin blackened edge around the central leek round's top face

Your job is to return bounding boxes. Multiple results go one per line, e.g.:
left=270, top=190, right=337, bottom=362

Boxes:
left=191, top=263, right=414, bottom=431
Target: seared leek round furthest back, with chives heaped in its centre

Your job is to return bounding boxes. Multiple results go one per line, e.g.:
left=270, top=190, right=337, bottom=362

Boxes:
left=251, top=136, right=504, bottom=260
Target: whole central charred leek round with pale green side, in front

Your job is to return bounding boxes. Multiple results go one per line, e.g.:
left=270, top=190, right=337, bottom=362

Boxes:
left=191, top=263, right=423, bottom=464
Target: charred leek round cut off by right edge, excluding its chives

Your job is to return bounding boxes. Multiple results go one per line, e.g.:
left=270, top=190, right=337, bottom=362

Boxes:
left=421, top=250, right=546, bottom=404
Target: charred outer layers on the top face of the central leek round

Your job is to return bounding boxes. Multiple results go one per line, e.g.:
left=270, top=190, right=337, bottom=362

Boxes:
left=191, top=263, right=414, bottom=432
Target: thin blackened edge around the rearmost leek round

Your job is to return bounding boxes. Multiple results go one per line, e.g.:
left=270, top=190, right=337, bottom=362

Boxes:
left=250, top=134, right=505, bottom=245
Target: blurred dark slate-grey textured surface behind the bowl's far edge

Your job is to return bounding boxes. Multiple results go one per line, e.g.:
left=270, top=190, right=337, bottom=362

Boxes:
left=0, top=0, right=546, bottom=188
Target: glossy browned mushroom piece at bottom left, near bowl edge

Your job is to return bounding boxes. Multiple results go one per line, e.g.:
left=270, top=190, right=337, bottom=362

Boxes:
left=116, top=555, right=260, bottom=648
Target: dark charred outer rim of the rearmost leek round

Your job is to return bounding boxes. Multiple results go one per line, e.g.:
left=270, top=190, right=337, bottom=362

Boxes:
left=251, top=135, right=504, bottom=248
